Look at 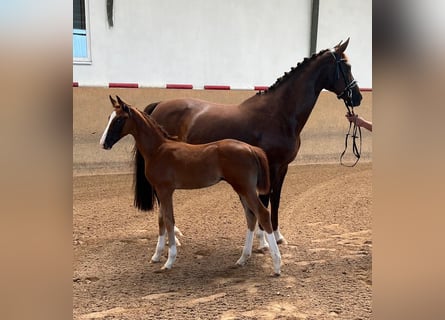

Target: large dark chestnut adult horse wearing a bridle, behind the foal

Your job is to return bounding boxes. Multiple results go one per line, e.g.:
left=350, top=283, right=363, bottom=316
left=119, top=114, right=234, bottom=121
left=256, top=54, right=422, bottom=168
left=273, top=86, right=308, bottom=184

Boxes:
left=135, top=39, right=362, bottom=248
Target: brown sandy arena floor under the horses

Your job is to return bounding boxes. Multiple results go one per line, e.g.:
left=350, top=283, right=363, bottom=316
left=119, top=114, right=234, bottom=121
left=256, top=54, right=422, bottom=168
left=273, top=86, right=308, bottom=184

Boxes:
left=73, top=161, right=372, bottom=319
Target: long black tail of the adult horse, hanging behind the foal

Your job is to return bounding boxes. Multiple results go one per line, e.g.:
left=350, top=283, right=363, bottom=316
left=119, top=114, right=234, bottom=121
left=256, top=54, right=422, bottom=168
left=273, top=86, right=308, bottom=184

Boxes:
left=133, top=146, right=156, bottom=211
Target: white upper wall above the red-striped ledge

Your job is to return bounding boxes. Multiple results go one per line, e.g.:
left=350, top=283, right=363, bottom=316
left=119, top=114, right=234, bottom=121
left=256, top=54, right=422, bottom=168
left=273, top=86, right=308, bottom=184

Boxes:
left=73, top=0, right=372, bottom=89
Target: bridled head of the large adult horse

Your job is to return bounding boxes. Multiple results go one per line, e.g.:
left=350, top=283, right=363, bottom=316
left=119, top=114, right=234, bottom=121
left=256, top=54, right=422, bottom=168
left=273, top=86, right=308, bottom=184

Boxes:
left=326, top=38, right=362, bottom=107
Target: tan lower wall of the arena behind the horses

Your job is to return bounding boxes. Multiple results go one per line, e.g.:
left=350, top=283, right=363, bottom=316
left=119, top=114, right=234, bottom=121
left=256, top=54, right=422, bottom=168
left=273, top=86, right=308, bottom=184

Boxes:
left=73, top=88, right=372, bottom=175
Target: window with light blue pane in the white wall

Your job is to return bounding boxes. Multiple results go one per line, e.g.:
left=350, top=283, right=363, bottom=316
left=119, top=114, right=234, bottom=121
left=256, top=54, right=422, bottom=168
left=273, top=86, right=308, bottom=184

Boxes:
left=73, top=0, right=91, bottom=63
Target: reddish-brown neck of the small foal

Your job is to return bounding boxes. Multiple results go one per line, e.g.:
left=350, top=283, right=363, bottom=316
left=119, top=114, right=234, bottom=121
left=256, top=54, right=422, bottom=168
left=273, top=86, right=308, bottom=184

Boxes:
left=133, top=112, right=166, bottom=157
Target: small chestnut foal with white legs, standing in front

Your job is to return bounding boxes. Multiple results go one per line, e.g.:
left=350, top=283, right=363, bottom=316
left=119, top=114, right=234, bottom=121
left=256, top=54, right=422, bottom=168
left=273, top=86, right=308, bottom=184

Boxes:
left=100, top=96, right=281, bottom=275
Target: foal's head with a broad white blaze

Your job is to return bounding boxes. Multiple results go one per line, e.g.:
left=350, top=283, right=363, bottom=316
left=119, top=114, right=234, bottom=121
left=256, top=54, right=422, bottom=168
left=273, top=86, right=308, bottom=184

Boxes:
left=100, top=96, right=131, bottom=150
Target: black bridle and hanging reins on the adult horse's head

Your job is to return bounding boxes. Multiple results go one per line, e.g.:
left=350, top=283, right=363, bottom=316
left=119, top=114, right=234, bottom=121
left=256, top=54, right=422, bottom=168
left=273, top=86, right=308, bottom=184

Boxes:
left=331, top=51, right=362, bottom=167
